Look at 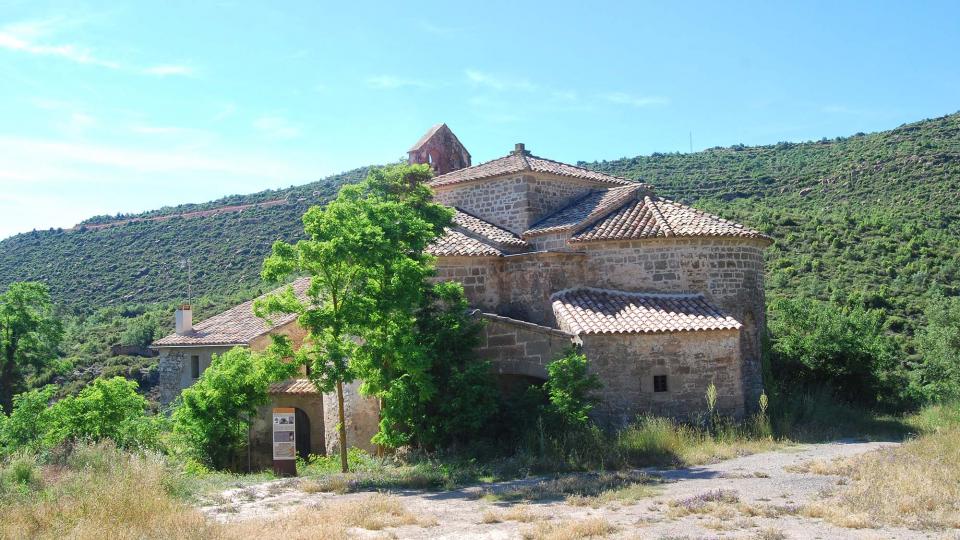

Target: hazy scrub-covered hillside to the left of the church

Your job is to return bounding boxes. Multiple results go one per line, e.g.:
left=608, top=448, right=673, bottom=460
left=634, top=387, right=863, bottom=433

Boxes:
left=0, top=168, right=367, bottom=313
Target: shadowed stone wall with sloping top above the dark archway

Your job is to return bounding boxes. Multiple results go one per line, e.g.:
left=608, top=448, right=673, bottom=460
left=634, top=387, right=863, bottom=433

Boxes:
left=477, top=313, right=574, bottom=379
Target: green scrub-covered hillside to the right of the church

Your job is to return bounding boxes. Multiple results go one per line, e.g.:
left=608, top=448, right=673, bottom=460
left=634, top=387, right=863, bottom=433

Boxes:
left=582, top=113, right=960, bottom=348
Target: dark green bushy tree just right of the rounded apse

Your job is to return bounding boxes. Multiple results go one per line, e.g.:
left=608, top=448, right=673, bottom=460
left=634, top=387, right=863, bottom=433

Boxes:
left=770, top=298, right=904, bottom=405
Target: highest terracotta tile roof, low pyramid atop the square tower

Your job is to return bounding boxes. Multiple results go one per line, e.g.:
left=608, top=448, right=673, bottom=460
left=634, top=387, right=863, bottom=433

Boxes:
left=430, top=152, right=636, bottom=187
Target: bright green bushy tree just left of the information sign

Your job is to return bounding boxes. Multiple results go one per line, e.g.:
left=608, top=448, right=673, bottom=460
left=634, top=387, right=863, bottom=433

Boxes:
left=172, top=347, right=290, bottom=469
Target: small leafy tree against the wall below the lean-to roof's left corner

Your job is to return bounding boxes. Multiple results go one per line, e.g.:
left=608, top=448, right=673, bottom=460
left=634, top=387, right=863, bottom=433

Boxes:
left=544, top=348, right=603, bottom=428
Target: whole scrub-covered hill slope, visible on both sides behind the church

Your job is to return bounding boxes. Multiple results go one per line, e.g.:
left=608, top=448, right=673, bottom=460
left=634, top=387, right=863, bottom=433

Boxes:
left=0, top=114, right=960, bottom=350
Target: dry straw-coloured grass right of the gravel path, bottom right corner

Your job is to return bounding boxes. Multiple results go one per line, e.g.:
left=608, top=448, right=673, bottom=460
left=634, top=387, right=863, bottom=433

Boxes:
left=805, top=427, right=960, bottom=529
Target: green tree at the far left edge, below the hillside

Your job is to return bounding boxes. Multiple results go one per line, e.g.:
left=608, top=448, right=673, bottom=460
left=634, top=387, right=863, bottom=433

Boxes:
left=0, top=282, right=63, bottom=412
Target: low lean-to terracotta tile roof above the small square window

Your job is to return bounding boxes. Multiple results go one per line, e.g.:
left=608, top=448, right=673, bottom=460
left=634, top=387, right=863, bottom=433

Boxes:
left=551, top=288, right=741, bottom=334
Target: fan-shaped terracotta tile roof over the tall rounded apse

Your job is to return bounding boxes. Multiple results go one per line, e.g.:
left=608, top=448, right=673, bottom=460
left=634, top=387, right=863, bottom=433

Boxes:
left=570, top=195, right=770, bottom=242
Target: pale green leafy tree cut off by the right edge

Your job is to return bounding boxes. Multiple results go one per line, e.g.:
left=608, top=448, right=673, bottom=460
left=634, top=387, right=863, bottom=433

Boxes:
left=914, top=296, right=960, bottom=402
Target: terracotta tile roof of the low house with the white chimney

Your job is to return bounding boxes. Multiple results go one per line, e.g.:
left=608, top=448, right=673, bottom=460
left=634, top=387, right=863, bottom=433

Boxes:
left=153, top=277, right=310, bottom=347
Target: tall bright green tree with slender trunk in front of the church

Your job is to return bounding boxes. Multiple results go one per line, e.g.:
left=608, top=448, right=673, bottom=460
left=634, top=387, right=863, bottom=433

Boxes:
left=256, top=162, right=452, bottom=471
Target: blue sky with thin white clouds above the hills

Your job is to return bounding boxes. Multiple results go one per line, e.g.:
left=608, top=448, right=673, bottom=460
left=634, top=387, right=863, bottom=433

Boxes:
left=0, top=0, right=960, bottom=238
